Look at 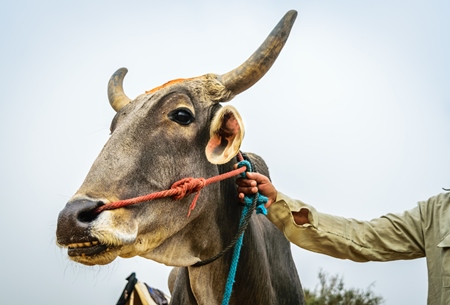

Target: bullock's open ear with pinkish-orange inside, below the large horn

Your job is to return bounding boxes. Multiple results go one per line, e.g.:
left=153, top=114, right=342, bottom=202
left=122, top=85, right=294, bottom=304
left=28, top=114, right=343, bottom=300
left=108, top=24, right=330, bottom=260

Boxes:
left=205, top=105, right=244, bottom=164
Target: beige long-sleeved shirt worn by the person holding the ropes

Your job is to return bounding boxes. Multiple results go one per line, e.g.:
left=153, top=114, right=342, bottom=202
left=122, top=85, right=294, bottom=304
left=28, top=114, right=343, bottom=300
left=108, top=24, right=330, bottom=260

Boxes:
left=267, top=192, right=450, bottom=305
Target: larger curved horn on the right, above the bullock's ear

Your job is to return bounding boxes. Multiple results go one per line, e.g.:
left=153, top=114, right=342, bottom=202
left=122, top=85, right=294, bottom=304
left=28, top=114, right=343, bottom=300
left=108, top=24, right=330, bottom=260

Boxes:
left=218, top=10, right=297, bottom=95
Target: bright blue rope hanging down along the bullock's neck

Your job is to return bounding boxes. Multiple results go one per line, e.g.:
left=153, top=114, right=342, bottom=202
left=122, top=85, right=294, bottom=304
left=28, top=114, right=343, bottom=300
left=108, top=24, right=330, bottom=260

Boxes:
left=222, top=160, right=268, bottom=305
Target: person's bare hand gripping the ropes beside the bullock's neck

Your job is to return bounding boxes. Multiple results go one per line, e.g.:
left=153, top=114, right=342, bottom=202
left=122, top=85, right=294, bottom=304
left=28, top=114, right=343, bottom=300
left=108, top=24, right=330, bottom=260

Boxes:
left=236, top=172, right=277, bottom=208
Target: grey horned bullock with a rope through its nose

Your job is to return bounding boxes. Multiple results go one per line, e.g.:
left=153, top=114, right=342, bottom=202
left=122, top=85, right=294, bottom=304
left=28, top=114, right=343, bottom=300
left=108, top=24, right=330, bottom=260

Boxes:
left=56, top=11, right=304, bottom=305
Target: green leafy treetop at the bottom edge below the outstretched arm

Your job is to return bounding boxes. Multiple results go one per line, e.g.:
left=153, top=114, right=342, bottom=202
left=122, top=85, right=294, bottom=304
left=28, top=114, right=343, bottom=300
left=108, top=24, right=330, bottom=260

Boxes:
left=304, top=270, right=384, bottom=305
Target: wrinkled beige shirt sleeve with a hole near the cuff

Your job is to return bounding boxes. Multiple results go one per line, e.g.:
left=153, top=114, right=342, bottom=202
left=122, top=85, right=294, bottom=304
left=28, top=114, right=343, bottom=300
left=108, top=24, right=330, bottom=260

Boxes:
left=267, top=192, right=425, bottom=262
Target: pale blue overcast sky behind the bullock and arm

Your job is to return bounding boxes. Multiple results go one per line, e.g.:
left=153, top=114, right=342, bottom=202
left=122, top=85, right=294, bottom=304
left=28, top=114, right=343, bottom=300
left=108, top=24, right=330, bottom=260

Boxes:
left=0, top=0, right=450, bottom=305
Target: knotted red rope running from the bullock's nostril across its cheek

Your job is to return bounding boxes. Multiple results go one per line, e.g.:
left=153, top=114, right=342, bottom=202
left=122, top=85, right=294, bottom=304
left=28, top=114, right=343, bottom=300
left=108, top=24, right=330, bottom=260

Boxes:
left=94, top=152, right=247, bottom=217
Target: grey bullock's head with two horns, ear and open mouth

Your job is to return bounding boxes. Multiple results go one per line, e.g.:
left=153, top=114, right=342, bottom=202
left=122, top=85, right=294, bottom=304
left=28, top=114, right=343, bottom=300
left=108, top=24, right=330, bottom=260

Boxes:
left=56, top=11, right=297, bottom=266
